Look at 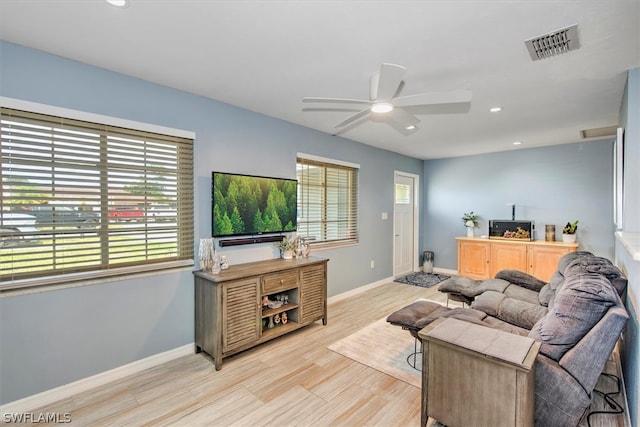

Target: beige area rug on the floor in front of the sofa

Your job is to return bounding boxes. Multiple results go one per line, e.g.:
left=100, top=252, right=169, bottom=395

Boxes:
left=328, top=317, right=422, bottom=388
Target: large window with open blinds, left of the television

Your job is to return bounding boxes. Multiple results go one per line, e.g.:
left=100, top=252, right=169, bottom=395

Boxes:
left=0, top=108, right=193, bottom=286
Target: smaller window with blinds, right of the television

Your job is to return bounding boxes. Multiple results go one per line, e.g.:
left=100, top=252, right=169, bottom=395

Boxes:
left=297, top=155, right=359, bottom=244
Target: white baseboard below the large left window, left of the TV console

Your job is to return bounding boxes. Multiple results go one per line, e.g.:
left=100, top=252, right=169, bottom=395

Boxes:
left=0, top=343, right=195, bottom=414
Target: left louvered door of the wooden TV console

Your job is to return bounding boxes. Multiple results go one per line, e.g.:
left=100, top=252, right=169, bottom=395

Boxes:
left=222, top=278, right=261, bottom=353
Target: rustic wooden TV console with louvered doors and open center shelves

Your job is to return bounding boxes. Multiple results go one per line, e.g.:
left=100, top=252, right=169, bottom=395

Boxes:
left=194, top=257, right=328, bottom=370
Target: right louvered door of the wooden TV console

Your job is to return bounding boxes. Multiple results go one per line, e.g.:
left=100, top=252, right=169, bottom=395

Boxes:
left=300, top=264, right=327, bottom=324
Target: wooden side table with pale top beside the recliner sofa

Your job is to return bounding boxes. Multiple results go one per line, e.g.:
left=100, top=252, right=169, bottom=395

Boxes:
left=418, top=318, right=540, bottom=427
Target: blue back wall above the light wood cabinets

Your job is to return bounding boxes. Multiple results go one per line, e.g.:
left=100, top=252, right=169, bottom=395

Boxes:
left=423, top=139, right=614, bottom=270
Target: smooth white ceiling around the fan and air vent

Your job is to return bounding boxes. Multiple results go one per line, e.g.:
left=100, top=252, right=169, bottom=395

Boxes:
left=0, top=0, right=640, bottom=159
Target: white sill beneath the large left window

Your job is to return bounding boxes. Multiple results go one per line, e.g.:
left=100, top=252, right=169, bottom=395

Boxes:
left=0, top=260, right=194, bottom=298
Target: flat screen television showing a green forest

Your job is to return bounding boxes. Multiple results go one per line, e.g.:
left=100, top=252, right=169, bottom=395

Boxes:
left=211, top=172, right=298, bottom=237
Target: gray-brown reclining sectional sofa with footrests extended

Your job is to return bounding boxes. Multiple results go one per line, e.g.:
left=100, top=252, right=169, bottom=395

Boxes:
left=388, top=252, right=628, bottom=427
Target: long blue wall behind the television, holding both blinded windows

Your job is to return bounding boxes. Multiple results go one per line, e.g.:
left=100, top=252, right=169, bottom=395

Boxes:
left=0, top=42, right=423, bottom=404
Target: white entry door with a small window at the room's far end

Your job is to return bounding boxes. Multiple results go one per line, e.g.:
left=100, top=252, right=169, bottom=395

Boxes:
left=393, top=172, right=418, bottom=277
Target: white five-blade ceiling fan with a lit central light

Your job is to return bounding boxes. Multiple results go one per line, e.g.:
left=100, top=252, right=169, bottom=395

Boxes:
left=302, top=63, right=472, bottom=135
